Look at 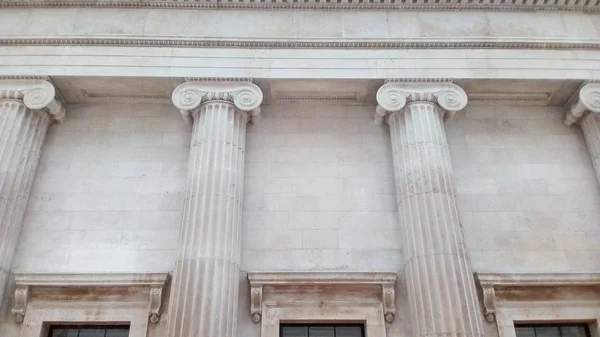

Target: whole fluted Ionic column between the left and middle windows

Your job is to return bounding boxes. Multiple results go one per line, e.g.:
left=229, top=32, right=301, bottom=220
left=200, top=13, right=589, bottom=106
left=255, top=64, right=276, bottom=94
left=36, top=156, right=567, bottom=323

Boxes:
left=167, top=82, right=263, bottom=337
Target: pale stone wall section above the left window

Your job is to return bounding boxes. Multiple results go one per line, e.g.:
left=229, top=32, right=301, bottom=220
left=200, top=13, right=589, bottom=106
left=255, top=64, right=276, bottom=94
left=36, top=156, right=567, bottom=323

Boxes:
left=13, top=104, right=190, bottom=273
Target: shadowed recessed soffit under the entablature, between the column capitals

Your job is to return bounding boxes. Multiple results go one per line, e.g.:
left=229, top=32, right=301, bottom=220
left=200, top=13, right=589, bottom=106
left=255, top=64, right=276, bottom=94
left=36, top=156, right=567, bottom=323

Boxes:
left=51, top=76, right=582, bottom=106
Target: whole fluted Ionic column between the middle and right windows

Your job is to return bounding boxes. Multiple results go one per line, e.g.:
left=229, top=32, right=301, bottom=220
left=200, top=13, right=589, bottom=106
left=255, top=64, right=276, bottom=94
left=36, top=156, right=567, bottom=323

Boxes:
left=375, top=83, right=483, bottom=337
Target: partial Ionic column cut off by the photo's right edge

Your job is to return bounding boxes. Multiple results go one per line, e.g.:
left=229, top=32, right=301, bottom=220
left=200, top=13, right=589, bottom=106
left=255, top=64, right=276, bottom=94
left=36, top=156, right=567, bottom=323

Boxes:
left=565, top=83, right=600, bottom=182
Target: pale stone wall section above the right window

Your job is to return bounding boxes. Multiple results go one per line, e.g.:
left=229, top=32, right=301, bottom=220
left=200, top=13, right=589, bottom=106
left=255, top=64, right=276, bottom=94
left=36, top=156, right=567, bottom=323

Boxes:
left=446, top=106, right=600, bottom=273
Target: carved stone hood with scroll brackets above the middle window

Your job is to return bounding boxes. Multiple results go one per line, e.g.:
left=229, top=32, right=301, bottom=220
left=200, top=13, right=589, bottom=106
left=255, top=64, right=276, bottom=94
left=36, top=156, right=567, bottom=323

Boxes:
left=248, top=272, right=396, bottom=323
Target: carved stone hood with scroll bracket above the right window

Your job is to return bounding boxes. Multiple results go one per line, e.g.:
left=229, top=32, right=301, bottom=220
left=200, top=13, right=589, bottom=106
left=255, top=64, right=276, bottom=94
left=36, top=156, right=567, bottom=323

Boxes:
left=475, top=273, right=600, bottom=322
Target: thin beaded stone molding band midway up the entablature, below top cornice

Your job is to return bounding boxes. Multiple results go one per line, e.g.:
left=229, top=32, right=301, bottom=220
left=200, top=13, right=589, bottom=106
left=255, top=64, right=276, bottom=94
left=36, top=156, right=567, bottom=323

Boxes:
left=0, top=36, right=600, bottom=50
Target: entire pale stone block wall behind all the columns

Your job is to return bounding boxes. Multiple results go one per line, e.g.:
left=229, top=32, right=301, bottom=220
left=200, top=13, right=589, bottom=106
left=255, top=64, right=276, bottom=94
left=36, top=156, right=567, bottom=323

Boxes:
left=5, top=103, right=600, bottom=337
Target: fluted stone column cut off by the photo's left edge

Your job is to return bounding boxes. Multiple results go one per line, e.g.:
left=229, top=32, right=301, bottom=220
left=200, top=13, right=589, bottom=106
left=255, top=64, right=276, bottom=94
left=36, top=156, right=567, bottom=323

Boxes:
left=0, top=80, right=65, bottom=303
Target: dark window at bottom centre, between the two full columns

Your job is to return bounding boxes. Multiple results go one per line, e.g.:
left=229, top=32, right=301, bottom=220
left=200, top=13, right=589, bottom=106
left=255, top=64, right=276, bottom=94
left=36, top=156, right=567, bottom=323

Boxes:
left=279, top=324, right=365, bottom=337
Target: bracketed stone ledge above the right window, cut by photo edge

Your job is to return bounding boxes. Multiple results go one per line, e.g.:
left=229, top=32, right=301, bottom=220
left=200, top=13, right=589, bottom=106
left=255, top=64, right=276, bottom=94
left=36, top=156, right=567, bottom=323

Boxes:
left=475, top=273, right=600, bottom=323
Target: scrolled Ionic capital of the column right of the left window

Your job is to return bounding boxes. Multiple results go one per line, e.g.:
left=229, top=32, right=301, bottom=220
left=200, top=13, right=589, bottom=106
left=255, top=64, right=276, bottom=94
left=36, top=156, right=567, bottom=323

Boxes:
left=172, top=81, right=263, bottom=124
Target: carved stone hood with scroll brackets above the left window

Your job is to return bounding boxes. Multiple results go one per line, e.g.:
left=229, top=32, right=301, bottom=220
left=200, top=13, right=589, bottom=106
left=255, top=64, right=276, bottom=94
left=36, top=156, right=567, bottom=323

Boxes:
left=12, top=273, right=169, bottom=323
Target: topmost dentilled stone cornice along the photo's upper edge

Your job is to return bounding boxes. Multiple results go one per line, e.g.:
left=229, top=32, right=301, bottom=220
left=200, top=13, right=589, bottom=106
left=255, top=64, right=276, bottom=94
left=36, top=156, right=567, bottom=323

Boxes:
left=0, top=0, right=600, bottom=12
